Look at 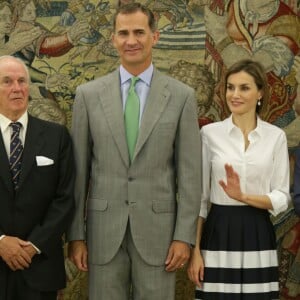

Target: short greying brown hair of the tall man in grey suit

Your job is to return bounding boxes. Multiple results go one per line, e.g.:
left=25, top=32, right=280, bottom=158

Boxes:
left=113, top=2, right=157, bottom=32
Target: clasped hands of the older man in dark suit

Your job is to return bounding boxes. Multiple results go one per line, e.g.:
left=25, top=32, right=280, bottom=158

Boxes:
left=0, top=236, right=31, bottom=271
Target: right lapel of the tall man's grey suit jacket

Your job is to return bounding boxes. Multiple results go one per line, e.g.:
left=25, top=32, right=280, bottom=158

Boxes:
left=133, top=69, right=170, bottom=159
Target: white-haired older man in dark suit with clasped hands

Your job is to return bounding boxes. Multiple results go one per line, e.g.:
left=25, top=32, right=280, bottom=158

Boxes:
left=0, top=56, right=74, bottom=300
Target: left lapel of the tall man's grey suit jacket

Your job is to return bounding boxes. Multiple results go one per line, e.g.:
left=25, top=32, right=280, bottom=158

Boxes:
left=99, top=69, right=129, bottom=167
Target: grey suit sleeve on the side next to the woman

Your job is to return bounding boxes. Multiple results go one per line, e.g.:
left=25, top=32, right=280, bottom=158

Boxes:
left=173, top=88, right=201, bottom=244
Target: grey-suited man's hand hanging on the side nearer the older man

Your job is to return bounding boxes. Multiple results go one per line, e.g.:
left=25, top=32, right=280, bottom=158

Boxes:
left=68, top=241, right=88, bottom=272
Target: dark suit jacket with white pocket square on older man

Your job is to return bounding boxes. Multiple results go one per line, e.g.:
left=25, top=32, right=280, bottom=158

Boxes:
left=0, top=115, right=74, bottom=291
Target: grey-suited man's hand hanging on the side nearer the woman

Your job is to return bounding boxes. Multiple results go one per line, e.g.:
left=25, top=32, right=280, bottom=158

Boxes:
left=165, top=241, right=190, bottom=272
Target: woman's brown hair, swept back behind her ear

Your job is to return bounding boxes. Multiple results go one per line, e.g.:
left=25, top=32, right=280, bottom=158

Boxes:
left=225, top=59, right=269, bottom=113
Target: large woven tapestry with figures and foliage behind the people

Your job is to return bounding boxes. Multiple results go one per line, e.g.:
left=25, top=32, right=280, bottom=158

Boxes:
left=0, top=0, right=300, bottom=300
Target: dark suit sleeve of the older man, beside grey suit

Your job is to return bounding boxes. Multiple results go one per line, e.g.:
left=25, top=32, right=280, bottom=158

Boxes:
left=28, top=126, right=75, bottom=255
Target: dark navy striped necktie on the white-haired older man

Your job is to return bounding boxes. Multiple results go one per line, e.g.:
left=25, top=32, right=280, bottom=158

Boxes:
left=9, top=122, right=23, bottom=190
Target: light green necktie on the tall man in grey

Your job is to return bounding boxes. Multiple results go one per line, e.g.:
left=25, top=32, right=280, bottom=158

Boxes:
left=125, top=77, right=140, bottom=161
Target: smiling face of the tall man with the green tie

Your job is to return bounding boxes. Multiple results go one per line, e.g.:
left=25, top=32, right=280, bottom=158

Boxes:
left=112, top=11, right=159, bottom=74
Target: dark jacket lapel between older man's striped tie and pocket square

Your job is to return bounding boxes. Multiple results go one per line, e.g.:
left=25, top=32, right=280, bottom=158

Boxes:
left=19, top=115, right=43, bottom=187
